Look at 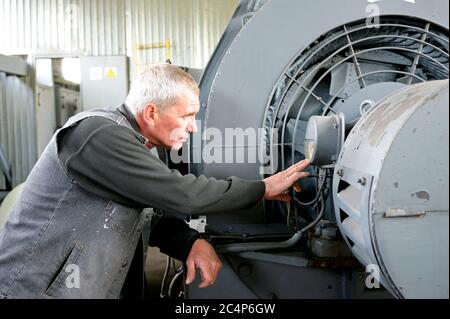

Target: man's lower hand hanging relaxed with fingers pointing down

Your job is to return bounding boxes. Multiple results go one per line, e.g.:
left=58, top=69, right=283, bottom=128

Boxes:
left=186, top=239, right=222, bottom=288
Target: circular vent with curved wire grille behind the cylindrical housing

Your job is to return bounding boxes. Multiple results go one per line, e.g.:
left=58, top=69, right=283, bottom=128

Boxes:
left=263, top=16, right=449, bottom=225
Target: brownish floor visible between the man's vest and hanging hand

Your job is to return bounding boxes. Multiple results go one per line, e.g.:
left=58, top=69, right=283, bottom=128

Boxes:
left=145, top=247, right=183, bottom=299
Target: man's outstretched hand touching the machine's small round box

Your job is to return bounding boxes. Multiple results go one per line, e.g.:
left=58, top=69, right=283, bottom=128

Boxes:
left=264, top=160, right=310, bottom=202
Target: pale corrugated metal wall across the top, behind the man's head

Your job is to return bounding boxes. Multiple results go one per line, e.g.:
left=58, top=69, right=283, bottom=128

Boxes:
left=0, top=0, right=239, bottom=73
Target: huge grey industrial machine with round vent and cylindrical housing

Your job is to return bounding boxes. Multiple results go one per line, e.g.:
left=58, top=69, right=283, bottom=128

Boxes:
left=168, top=0, right=449, bottom=298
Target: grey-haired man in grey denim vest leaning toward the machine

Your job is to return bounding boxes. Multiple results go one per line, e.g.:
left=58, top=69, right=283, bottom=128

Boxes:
left=0, top=64, right=309, bottom=298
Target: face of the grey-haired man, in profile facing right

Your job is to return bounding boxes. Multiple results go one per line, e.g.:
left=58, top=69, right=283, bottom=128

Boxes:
left=147, top=94, right=200, bottom=150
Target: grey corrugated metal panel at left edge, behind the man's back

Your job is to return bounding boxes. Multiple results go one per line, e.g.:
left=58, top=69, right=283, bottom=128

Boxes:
left=0, top=73, right=36, bottom=186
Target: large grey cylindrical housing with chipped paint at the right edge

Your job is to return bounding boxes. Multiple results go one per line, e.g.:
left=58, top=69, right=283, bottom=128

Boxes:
left=335, top=80, right=449, bottom=298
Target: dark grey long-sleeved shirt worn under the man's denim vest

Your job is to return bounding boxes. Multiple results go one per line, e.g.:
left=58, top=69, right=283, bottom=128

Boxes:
left=59, top=105, right=265, bottom=260
